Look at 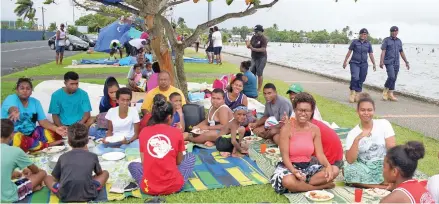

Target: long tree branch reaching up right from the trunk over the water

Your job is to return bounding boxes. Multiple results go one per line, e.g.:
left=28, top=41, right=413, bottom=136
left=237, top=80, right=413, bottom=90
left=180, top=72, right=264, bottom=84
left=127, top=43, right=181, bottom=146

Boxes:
left=184, top=0, right=279, bottom=47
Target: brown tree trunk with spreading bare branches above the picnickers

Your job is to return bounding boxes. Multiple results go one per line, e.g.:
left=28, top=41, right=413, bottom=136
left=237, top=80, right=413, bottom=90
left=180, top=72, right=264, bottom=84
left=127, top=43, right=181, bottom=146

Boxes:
left=44, top=0, right=279, bottom=94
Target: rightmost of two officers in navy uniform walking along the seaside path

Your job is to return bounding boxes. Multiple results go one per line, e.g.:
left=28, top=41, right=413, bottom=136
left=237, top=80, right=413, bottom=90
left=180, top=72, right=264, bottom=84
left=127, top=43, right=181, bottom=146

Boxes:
left=380, top=26, right=410, bottom=101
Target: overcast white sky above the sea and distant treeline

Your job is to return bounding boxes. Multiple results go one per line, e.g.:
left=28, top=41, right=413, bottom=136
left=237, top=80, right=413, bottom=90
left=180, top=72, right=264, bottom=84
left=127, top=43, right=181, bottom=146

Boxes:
left=1, top=0, right=439, bottom=44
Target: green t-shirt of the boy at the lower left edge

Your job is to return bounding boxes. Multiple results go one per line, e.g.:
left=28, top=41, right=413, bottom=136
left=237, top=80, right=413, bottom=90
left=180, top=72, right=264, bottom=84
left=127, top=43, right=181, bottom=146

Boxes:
left=1, top=143, right=32, bottom=202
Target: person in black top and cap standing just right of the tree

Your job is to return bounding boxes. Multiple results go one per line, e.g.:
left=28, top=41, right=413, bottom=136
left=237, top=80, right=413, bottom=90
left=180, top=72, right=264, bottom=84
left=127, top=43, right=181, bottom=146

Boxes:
left=247, top=25, right=268, bottom=93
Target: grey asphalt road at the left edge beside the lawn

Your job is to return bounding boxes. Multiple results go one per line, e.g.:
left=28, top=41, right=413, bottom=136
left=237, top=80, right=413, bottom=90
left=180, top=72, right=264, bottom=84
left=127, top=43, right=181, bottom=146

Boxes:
left=1, top=40, right=78, bottom=76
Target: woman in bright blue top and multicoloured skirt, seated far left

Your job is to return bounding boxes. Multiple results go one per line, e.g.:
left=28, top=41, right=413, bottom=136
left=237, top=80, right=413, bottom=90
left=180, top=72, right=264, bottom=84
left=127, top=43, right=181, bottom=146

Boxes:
left=1, top=78, right=67, bottom=152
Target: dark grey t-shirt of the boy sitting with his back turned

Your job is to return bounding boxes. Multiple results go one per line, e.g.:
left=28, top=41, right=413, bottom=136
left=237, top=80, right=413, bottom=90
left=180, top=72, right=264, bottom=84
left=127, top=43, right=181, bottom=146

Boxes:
left=52, top=149, right=102, bottom=202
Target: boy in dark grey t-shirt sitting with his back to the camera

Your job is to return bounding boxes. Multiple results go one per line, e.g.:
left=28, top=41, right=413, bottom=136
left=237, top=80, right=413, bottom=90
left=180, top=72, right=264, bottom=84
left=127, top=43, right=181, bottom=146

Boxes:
left=44, top=123, right=109, bottom=202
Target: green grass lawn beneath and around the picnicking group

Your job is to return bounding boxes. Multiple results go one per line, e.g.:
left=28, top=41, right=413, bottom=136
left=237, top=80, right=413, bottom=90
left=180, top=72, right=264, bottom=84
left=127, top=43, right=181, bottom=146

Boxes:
left=1, top=51, right=439, bottom=203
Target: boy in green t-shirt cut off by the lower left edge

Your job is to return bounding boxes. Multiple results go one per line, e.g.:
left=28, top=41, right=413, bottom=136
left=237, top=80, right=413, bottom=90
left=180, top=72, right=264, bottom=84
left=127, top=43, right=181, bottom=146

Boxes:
left=1, top=119, right=46, bottom=202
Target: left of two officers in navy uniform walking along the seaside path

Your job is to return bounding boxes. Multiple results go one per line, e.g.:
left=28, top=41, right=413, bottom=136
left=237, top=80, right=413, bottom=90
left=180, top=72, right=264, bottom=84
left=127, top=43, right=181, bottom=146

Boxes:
left=343, top=28, right=376, bottom=103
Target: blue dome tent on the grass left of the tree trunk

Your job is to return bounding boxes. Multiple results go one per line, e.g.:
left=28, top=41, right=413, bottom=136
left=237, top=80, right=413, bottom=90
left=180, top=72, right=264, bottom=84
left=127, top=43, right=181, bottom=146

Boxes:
left=94, top=21, right=131, bottom=52
